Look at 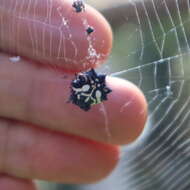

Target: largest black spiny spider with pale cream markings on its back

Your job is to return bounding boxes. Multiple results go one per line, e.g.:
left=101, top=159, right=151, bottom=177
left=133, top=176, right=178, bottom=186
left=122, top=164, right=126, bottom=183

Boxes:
left=69, top=69, right=112, bottom=111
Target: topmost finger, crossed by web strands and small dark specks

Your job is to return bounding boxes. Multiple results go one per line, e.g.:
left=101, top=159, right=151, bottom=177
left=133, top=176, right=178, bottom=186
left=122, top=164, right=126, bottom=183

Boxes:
left=0, top=0, right=112, bottom=72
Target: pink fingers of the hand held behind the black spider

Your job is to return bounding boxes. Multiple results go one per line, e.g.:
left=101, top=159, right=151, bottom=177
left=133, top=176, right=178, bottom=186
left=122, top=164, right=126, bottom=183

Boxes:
left=0, top=0, right=147, bottom=190
